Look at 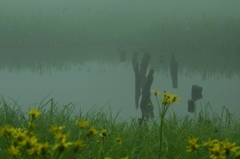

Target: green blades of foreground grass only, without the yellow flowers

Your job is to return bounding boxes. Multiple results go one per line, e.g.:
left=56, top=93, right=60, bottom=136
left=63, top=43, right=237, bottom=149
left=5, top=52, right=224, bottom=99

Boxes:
left=0, top=95, right=240, bottom=159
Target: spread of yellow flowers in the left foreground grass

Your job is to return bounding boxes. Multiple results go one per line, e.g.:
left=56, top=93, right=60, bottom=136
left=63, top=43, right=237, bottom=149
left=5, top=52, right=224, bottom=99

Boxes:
left=0, top=109, right=128, bottom=159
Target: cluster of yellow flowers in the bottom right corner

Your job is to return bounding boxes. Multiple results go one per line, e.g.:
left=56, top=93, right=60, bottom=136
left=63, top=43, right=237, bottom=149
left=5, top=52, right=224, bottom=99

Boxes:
left=187, top=137, right=240, bottom=159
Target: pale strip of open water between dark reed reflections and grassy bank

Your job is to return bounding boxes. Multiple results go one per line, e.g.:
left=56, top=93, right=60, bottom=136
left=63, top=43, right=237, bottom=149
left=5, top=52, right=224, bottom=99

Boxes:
left=0, top=62, right=240, bottom=119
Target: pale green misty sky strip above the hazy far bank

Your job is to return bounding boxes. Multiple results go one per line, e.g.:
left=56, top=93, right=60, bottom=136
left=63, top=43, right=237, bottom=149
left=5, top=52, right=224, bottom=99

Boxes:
left=0, top=0, right=240, bottom=18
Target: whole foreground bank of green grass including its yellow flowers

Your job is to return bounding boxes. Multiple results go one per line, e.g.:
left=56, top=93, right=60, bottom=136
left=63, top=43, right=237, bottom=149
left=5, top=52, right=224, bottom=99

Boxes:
left=0, top=91, right=240, bottom=159
